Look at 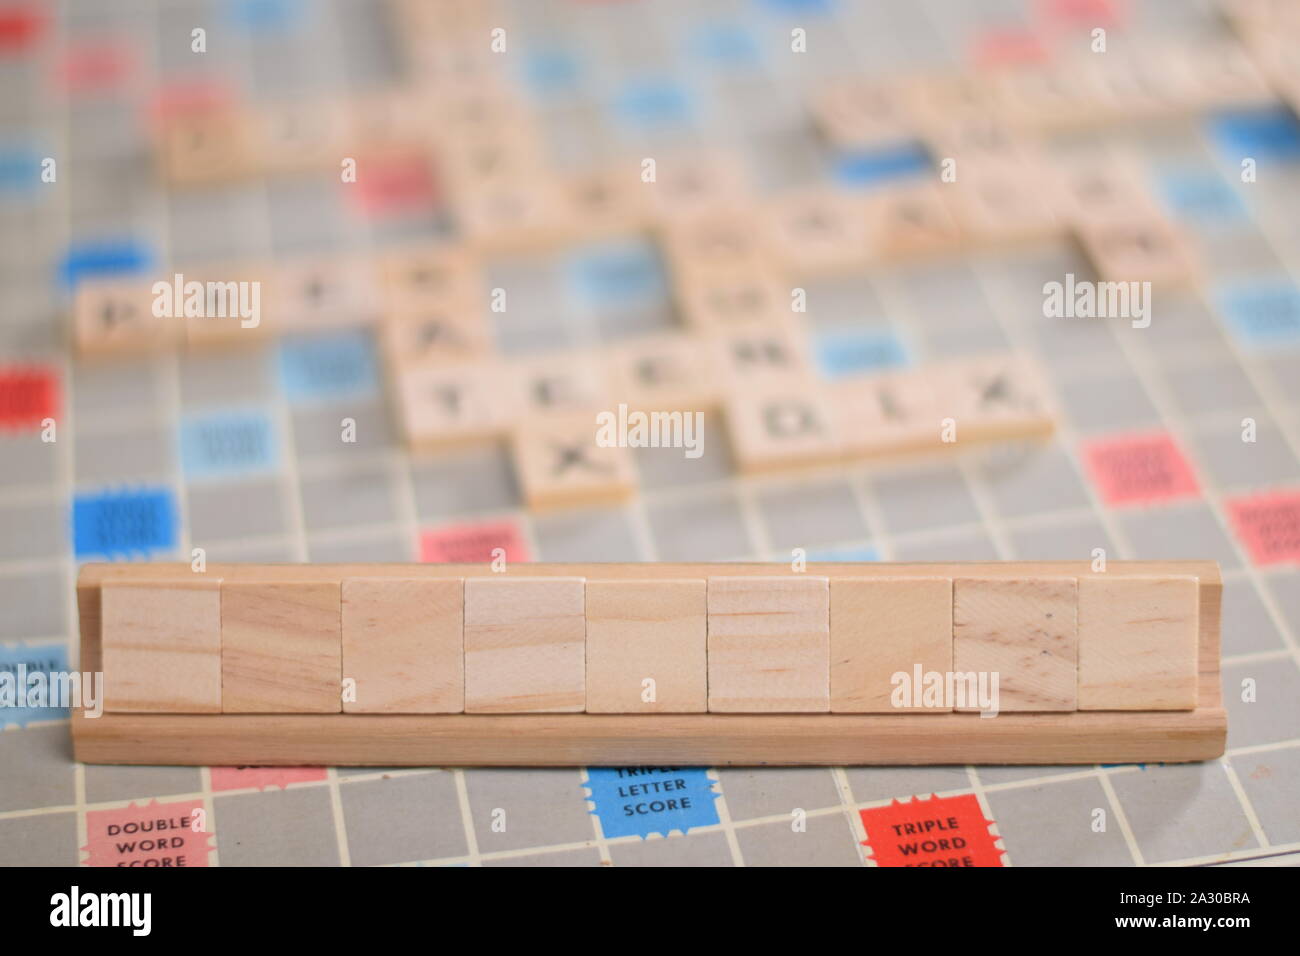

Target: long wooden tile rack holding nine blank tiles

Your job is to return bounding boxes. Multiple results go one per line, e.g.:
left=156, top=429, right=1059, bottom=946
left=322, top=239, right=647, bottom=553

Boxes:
left=72, top=562, right=1226, bottom=766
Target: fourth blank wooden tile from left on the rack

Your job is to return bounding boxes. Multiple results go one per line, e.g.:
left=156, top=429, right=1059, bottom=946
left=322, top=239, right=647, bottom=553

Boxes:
left=465, top=575, right=586, bottom=714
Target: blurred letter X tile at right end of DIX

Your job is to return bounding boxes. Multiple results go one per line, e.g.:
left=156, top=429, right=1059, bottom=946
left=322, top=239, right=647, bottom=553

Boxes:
left=928, top=352, right=1057, bottom=447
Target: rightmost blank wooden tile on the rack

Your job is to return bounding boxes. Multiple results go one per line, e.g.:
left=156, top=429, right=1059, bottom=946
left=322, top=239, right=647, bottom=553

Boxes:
left=1079, top=575, right=1200, bottom=710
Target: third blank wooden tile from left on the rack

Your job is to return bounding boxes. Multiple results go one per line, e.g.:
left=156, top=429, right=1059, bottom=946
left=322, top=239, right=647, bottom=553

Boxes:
left=342, top=578, right=465, bottom=714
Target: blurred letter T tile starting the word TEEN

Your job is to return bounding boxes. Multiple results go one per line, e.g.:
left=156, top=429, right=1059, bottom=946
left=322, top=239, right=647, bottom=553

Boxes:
left=393, top=362, right=519, bottom=449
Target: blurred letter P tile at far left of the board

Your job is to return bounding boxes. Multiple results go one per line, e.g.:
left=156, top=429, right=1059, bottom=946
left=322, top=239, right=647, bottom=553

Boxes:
left=73, top=280, right=185, bottom=356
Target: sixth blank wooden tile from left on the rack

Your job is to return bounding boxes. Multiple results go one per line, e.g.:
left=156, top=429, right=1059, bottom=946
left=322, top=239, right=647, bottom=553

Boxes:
left=709, top=575, right=831, bottom=714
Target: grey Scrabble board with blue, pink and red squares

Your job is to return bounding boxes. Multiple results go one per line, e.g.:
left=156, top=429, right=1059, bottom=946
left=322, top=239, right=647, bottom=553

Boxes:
left=0, top=0, right=1300, bottom=866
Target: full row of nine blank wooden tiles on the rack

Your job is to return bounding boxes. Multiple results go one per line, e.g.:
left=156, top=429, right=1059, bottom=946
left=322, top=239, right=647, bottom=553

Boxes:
left=103, top=575, right=1199, bottom=714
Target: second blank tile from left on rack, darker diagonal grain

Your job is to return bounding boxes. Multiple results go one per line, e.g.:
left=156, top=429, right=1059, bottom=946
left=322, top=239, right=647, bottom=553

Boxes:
left=221, top=581, right=342, bottom=714
